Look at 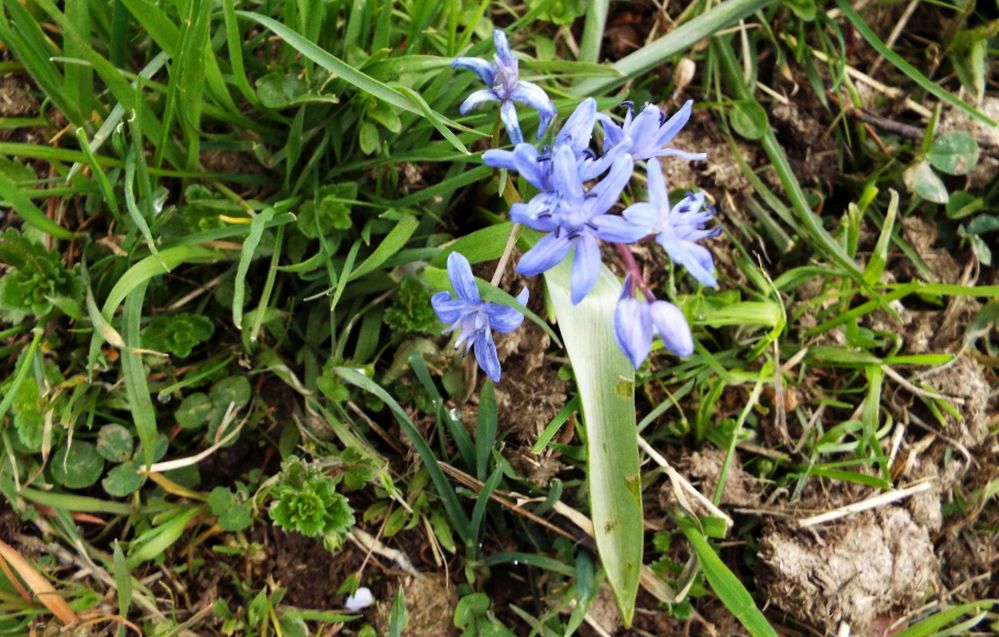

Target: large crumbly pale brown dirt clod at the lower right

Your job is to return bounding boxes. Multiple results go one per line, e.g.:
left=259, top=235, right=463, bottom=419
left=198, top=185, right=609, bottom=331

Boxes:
left=759, top=507, right=939, bottom=635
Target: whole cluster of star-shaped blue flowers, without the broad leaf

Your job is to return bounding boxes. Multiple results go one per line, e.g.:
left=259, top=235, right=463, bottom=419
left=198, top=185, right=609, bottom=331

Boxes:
left=432, top=31, right=721, bottom=381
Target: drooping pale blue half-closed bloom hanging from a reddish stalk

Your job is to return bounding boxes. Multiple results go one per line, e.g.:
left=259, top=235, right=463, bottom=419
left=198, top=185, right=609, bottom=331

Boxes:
left=614, top=274, right=694, bottom=369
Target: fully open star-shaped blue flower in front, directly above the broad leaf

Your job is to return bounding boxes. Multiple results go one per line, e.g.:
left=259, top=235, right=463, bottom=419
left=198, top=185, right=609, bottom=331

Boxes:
left=510, top=144, right=651, bottom=303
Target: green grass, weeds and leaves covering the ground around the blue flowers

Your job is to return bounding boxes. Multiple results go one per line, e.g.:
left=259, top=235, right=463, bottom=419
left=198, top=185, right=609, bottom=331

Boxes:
left=0, top=0, right=999, bottom=636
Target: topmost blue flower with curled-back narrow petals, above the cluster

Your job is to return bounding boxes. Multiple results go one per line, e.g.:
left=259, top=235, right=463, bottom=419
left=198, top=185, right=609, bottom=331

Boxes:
left=451, top=29, right=556, bottom=144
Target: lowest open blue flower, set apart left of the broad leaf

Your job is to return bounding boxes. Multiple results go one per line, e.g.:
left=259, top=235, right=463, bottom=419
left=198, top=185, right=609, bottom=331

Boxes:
left=430, top=252, right=528, bottom=383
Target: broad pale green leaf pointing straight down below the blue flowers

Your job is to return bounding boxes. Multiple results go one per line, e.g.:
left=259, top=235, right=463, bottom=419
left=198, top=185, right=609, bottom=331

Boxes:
left=545, top=261, right=643, bottom=626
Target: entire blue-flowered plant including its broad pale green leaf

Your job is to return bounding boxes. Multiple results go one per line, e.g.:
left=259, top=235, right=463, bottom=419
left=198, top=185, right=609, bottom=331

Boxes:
left=432, top=31, right=721, bottom=625
